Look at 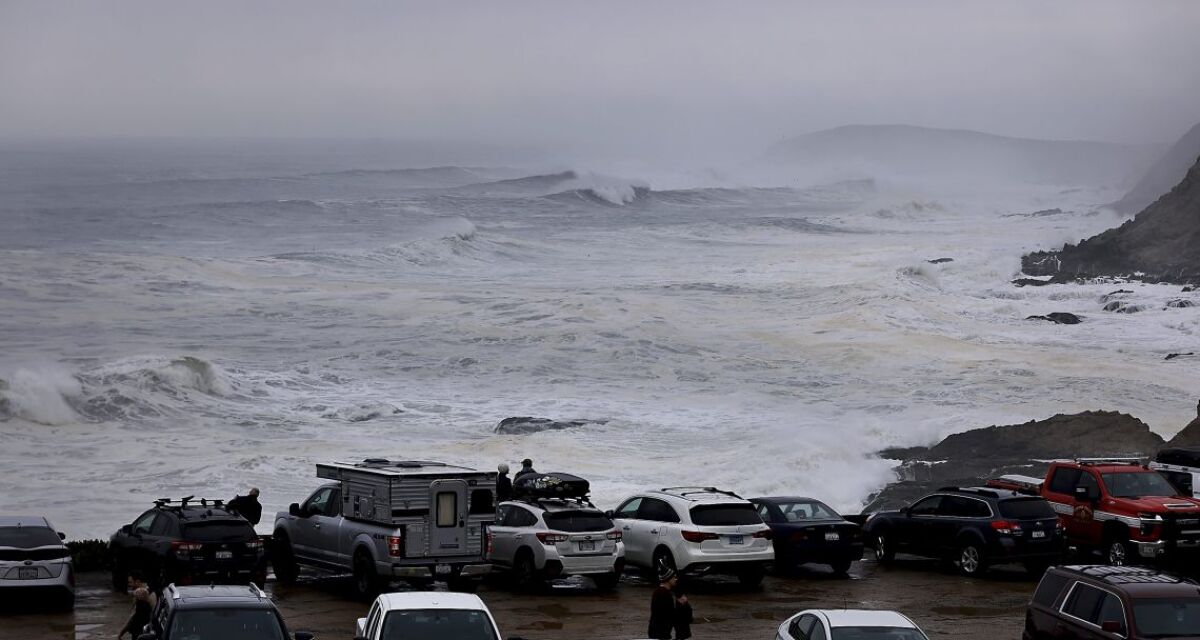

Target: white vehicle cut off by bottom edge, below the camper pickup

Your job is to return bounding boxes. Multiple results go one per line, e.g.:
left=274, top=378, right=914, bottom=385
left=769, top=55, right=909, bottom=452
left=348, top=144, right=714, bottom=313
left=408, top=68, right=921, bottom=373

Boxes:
left=354, top=591, right=522, bottom=640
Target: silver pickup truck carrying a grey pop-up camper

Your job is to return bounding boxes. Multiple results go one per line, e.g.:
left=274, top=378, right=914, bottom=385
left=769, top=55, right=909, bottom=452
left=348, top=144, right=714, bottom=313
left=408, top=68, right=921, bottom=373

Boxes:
left=271, top=457, right=496, bottom=598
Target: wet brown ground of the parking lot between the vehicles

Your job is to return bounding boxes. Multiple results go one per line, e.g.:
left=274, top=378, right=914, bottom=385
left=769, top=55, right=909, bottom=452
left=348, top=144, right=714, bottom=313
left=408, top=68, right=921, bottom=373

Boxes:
left=0, top=558, right=1037, bottom=640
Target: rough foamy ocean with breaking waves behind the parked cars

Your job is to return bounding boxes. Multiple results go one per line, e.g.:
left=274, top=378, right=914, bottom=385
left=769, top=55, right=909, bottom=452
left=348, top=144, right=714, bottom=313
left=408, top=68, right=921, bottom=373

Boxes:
left=0, top=142, right=1200, bottom=538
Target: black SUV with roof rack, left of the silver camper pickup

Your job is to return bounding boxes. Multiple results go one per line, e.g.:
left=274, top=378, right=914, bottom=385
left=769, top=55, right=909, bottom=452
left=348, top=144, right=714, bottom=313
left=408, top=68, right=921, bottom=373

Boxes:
left=109, top=497, right=266, bottom=591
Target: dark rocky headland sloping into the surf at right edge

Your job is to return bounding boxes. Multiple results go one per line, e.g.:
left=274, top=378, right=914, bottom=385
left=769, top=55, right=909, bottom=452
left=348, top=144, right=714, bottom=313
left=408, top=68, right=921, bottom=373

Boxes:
left=1021, top=153, right=1200, bottom=282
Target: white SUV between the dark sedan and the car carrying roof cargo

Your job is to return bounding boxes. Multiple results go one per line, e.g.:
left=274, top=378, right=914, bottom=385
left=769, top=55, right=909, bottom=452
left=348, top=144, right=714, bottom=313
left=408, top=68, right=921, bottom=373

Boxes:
left=608, top=486, right=775, bottom=586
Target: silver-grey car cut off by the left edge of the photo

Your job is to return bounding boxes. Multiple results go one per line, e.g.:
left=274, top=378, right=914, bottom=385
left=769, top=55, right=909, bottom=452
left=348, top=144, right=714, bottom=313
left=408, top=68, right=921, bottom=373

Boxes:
left=0, top=515, right=74, bottom=609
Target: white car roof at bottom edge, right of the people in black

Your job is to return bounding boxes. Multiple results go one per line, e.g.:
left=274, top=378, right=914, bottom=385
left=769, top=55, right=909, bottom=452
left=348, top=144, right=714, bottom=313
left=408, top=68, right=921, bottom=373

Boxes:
left=775, top=609, right=929, bottom=640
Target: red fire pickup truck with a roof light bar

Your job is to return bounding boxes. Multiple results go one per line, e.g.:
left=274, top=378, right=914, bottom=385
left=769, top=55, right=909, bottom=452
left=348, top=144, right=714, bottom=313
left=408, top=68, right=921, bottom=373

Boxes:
left=988, top=459, right=1200, bottom=564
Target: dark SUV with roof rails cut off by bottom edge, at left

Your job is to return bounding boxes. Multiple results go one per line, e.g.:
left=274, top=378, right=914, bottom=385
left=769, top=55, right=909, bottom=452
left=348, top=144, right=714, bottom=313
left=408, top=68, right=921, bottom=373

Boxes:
left=138, top=585, right=312, bottom=640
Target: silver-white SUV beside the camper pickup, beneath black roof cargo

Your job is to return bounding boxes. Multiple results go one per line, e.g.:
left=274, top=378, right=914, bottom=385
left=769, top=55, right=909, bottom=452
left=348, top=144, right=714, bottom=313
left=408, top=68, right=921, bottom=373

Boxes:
left=487, top=498, right=625, bottom=591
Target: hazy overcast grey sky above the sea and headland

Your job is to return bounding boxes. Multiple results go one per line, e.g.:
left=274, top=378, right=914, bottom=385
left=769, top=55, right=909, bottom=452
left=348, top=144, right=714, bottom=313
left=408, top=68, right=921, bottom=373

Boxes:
left=0, top=0, right=1200, bottom=158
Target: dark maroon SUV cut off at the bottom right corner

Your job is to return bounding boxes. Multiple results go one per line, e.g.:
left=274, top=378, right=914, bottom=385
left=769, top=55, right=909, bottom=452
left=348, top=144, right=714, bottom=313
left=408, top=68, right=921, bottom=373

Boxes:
left=1021, top=566, right=1200, bottom=640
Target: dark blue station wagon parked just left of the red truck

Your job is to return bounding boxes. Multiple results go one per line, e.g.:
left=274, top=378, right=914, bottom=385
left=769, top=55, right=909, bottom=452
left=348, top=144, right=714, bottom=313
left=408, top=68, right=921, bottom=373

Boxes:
left=864, top=486, right=1066, bottom=575
